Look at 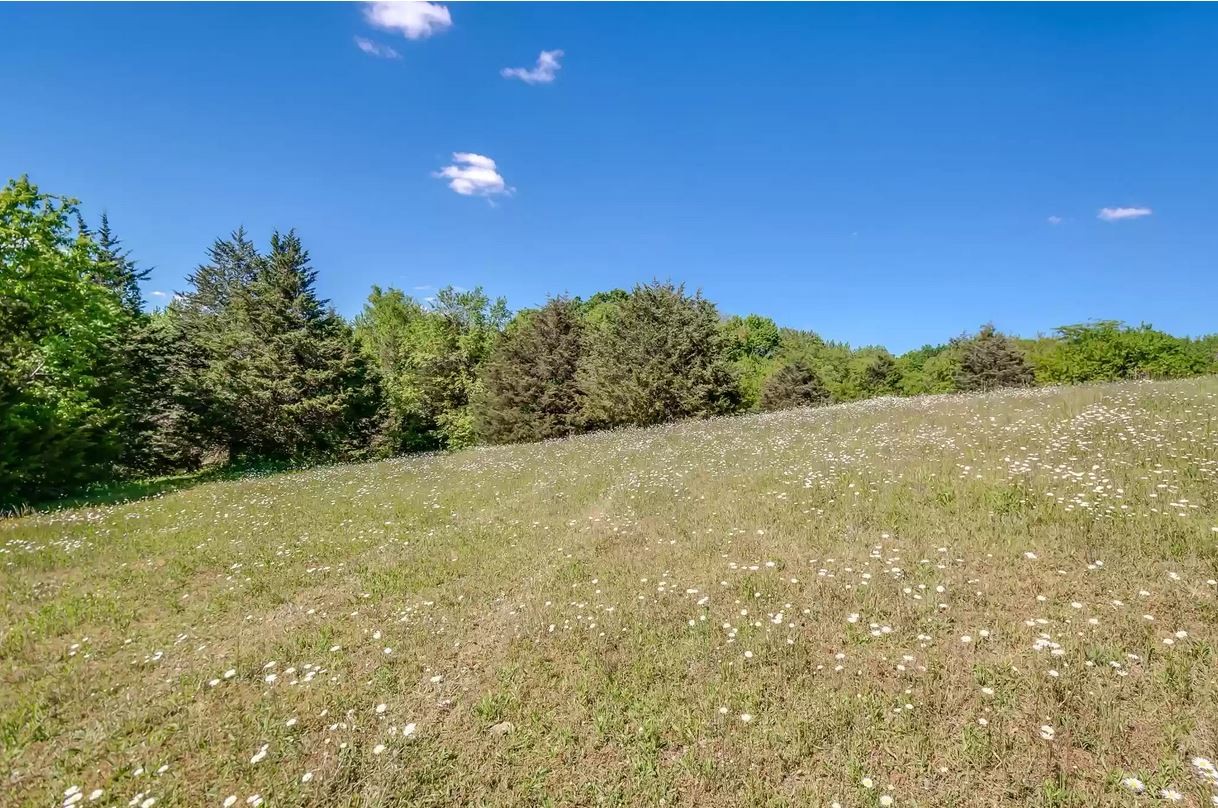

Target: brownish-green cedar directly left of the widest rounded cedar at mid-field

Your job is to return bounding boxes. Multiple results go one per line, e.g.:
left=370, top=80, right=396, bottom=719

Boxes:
left=475, top=297, right=583, bottom=444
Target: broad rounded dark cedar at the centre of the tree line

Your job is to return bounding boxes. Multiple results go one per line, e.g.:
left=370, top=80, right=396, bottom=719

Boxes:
left=580, top=283, right=741, bottom=427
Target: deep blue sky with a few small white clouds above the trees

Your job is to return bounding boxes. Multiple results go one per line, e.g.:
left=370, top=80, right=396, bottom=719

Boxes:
left=0, top=4, right=1218, bottom=350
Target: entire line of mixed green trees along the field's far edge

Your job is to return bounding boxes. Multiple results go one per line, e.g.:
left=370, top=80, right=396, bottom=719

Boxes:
left=0, top=178, right=1218, bottom=506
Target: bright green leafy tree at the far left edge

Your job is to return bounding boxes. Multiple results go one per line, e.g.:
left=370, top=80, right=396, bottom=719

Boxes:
left=0, top=177, right=128, bottom=505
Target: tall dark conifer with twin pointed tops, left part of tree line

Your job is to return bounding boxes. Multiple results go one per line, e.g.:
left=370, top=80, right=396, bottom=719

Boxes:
left=168, top=230, right=380, bottom=463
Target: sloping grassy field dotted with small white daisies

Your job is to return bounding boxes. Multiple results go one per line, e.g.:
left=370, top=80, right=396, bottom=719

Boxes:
left=0, top=379, right=1218, bottom=808
